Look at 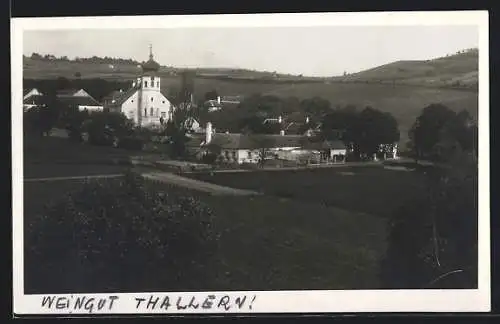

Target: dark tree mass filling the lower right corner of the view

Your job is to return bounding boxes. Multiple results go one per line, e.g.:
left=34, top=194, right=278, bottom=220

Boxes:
left=382, top=159, right=478, bottom=289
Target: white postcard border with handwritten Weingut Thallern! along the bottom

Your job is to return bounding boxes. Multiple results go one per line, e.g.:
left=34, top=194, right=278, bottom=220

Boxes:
left=11, top=11, right=491, bottom=315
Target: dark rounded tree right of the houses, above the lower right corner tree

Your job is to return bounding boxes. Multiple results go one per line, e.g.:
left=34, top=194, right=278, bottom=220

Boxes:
left=408, top=104, right=456, bottom=160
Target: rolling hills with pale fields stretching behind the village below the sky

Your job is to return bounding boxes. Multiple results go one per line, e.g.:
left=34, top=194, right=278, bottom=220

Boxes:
left=23, top=49, right=478, bottom=143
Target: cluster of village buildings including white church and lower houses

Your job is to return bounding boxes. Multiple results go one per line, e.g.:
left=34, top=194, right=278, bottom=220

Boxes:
left=23, top=48, right=398, bottom=175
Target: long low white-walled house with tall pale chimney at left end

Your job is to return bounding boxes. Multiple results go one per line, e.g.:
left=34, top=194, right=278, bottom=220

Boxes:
left=187, top=122, right=346, bottom=164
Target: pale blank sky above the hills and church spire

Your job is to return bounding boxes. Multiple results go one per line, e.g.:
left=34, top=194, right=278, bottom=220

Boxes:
left=23, top=26, right=479, bottom=76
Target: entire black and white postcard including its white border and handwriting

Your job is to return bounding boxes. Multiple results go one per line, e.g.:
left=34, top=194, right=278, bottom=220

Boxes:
left=12, top=11, right=490, bottom=314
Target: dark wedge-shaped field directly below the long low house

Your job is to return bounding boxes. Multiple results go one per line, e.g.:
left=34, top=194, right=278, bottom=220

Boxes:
left=186, top=166, right=424, bottom=217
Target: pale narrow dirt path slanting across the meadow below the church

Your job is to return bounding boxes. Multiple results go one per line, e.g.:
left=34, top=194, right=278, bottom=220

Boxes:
left=142, top=172, right=260, bottom=196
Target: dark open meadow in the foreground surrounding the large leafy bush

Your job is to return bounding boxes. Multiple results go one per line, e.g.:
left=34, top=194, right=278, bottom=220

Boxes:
left=24, top=177, right=386, bottom=293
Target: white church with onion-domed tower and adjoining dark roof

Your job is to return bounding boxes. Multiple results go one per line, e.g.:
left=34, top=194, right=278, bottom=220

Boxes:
left=103, top=46, right=174, bottom=127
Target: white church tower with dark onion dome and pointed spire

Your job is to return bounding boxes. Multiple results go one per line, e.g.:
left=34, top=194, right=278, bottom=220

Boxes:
left=137, top=45, right=164, bottom=126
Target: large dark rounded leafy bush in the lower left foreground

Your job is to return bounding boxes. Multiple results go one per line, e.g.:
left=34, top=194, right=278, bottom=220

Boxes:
left=26, top=174, right=218, bottom=293
